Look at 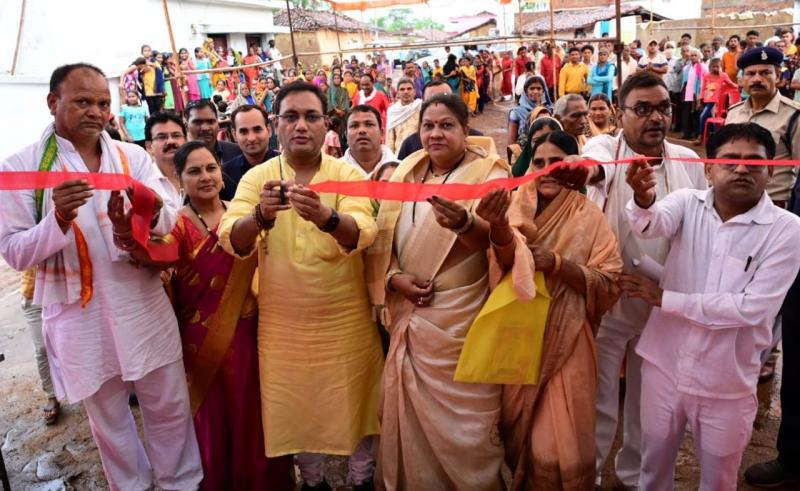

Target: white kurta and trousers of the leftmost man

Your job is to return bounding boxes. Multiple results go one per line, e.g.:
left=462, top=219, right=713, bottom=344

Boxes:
left=0, top=125, right=202, bottom=491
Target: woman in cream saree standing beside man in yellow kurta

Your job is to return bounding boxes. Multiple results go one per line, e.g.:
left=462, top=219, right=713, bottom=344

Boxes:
left=367, top=95, right=509, bottom=491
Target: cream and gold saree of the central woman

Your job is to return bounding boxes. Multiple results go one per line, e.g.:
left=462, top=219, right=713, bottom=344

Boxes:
left=367, top=139, right=508, bottom=491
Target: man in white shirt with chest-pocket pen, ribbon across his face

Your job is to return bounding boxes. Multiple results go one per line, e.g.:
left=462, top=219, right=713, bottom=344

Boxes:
left=621, top=123, right=800, bottom=490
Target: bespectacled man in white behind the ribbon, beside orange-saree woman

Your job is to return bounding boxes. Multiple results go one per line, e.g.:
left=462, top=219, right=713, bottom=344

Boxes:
left=583, top=71, right=707, bottom=489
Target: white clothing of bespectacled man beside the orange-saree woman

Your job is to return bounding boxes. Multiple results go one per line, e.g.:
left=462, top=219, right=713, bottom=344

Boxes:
left=583, top=132, right=707, bottom=488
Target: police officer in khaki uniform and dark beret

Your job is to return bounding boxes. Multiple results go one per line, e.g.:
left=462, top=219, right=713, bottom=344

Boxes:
left=725, top=47, right=800, bottom=208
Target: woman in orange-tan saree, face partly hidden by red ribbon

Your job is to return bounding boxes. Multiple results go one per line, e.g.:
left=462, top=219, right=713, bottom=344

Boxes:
left=478, top=131, right=622, bottom=490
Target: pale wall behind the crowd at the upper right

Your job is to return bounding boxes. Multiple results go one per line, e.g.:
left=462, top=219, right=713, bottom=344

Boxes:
left=636, top=12, right=793, bottom=46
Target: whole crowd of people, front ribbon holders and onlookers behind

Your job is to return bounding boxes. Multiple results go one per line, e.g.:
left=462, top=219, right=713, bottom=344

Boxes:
left=0, top=23, right=800, bottom=490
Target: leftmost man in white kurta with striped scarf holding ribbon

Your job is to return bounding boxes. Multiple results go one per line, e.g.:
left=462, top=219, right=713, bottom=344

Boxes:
left=0, top=63, right=203, bottom=490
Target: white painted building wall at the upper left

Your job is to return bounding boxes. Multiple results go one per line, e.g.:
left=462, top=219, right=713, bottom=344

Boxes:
left=0, top=0, right=288, bottom=158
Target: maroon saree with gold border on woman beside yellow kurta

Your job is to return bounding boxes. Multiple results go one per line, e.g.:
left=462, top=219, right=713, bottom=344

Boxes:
left=172, top=215, right=294, bottom=490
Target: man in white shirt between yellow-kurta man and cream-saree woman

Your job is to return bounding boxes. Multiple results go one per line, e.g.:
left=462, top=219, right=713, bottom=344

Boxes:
left=343, top=104, right=397, bottom=178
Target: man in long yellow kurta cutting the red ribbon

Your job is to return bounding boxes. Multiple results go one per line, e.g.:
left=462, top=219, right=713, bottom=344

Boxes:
left=219, top=82, right=383, bottom=489
